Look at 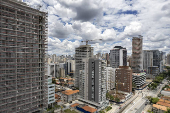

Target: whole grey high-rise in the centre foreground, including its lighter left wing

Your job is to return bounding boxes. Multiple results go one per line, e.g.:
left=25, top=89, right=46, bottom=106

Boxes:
left=80, top=58, right=106, bottom=104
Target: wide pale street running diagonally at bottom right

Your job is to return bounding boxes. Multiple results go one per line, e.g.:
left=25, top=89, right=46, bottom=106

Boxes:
left=107, top=80, right=168, bottom=113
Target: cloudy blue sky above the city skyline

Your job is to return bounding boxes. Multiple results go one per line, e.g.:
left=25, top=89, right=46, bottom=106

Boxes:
left=24, top=0, right=170, bottom=55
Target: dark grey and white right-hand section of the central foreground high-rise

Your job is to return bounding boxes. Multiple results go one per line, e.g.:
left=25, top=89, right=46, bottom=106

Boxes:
left=88, top=58, right=106, bottom=103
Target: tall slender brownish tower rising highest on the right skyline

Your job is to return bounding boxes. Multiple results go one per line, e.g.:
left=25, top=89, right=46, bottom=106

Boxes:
left=131, top=35, right=143, bottom=73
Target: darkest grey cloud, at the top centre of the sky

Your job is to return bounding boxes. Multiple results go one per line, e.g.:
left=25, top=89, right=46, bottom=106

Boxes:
left=59, top=0, right=103, bottom=22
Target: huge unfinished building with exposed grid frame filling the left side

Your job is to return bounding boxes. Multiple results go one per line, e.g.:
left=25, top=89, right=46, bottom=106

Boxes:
left=0, top=0, right=48, bottom=113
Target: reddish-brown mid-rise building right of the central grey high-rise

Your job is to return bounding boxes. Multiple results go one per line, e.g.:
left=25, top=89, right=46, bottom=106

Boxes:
left=115, top=66, right=132, bottom=93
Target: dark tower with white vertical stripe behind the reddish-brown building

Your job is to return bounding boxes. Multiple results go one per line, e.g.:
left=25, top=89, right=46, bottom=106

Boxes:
left=110, top=46, right=127, bottom=68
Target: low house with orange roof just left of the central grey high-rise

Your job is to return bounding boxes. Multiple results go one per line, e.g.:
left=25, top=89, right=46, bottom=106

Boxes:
left=61, top=90, right=79, bottom=103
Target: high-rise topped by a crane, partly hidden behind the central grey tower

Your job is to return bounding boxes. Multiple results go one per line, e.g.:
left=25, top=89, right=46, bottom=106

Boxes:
left=74, top=45, right=93, bottom=88
